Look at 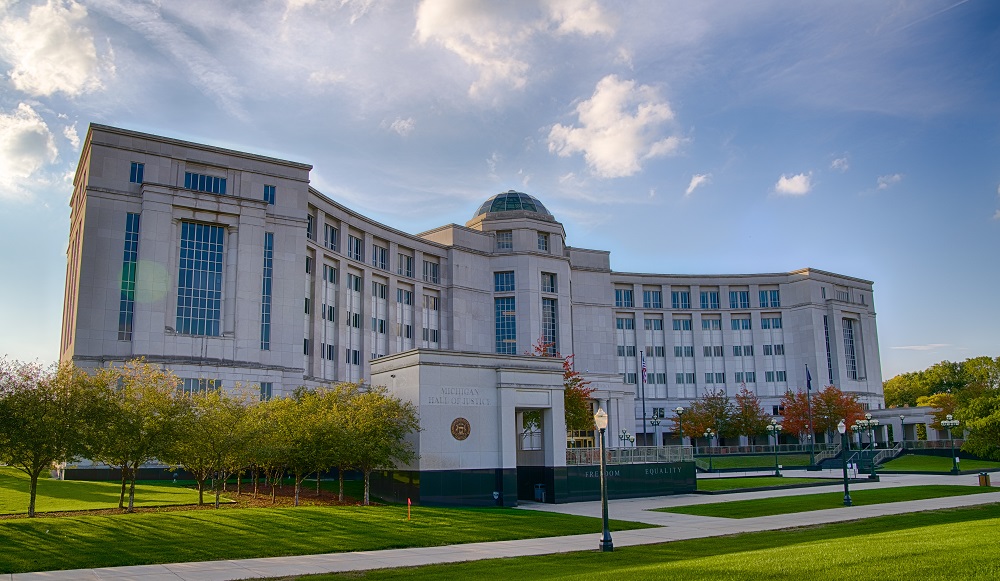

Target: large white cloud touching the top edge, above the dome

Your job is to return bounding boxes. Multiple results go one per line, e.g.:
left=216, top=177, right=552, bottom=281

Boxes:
left=415, top=0, right=613, bottom=97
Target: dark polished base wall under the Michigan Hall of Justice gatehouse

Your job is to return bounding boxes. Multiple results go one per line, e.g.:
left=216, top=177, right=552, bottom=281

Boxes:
left=371, top=462, right=697, bottom=506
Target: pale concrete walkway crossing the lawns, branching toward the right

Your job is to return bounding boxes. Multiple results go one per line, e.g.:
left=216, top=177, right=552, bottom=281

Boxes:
left=9, top=471, right=1000, bottom=581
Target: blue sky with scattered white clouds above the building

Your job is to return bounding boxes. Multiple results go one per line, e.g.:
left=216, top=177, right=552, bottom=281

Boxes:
left=0, top=0, right=1000, bottom=379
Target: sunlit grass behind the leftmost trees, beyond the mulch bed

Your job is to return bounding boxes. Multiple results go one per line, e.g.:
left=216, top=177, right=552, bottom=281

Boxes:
left=0, top=467, right=207, bottom=514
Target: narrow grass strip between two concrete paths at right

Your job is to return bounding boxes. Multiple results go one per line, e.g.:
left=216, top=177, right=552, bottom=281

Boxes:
left=656, top=485, right=996, bottom=518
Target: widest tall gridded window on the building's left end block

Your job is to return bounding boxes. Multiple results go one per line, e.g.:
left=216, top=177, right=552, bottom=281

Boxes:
left=177, top=222, right=225, bottom=337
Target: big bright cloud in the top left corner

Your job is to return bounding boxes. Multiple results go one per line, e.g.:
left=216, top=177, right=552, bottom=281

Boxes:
left=0, top=0, right=101, bottom=97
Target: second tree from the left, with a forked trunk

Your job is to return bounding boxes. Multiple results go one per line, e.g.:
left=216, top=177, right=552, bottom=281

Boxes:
left=92, top=360, right=184, bottom=512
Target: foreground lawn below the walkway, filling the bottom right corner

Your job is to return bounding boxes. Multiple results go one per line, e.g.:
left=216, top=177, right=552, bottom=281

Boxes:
left=299, top=504, right=1000, bottom=581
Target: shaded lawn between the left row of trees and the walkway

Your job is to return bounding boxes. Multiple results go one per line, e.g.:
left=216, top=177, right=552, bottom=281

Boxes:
left=0, top=506, right=648, bottom=573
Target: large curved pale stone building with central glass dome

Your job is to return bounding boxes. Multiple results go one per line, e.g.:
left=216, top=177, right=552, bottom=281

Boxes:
left=60, top=125, right=884, bottom=444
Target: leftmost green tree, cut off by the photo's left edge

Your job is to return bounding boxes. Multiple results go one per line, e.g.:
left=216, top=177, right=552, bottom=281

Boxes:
left=0, top=359, right=98, bottom=517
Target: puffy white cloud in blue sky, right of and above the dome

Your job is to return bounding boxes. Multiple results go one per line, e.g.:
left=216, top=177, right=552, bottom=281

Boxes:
left=548, top=75, right=683, bottom=178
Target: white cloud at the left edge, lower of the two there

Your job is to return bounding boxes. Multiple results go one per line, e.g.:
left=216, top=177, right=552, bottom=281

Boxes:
left=0, top=103, right=59, bottom=199
